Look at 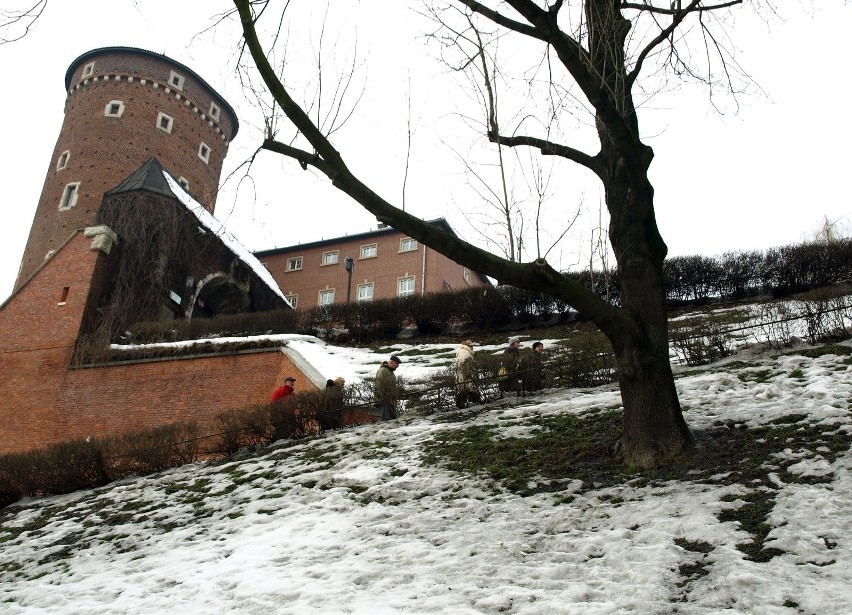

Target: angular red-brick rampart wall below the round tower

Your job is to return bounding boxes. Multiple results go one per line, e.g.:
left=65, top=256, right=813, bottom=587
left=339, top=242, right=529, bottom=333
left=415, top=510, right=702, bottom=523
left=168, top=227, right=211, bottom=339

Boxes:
left=0, top=231, right=320, bottom=454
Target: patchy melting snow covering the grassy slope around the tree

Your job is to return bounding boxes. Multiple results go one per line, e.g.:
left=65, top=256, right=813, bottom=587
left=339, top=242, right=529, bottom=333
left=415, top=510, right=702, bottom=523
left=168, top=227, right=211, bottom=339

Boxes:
left=0, top=339, right=852, bottom=615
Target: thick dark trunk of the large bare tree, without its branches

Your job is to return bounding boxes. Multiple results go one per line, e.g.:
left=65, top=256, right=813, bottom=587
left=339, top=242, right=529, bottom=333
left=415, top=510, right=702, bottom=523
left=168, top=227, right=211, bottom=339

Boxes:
left=604, top=142, right=693, bottom=468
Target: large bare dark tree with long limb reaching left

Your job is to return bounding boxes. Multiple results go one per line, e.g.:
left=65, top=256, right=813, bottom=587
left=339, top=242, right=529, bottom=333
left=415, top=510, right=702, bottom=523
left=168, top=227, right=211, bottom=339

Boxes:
left=234, top=0, right=771, bottom=467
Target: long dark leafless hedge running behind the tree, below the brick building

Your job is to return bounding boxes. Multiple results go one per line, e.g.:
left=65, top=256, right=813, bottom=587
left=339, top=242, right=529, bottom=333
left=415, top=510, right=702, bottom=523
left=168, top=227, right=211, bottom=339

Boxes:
left=114, top=240, right=852, bottom=344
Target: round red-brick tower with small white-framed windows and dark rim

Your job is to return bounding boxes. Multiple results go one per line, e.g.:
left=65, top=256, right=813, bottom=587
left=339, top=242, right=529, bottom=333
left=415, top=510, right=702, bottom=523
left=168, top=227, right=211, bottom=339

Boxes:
left=15, top=47, right=239, bottom=288
